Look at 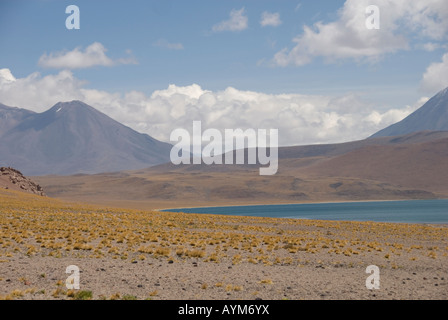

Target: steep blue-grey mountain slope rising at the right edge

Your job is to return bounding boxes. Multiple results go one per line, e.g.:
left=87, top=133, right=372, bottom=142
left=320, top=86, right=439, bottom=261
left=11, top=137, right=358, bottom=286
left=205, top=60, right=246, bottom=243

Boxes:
left=371, top=88, right=448, bottom=138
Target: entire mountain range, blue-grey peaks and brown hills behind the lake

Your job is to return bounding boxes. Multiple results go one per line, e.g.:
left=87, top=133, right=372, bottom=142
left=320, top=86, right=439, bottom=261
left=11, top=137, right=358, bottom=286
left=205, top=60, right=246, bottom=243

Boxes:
left=0, top=85, right=448, bottom=209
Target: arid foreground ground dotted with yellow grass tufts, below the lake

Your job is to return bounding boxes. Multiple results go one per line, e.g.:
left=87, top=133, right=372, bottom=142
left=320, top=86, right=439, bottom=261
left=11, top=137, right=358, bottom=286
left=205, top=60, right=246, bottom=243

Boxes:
left=0, top=190, right=448, bottom=300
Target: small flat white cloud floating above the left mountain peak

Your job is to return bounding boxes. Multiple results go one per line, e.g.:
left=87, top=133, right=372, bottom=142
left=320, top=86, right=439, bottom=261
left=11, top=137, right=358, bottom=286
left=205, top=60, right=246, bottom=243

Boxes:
left=38, top=42, right=136, bottom=69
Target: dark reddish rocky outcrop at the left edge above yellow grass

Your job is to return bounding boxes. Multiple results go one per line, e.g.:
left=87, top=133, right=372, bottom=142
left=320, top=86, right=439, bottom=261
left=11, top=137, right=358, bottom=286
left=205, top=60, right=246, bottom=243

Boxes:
left=0, top=167, right=45, bottom=196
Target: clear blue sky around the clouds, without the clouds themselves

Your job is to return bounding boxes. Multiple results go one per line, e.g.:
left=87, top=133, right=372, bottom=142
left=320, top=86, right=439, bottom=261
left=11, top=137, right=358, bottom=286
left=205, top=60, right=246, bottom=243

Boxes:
left=0, top=0, right=343, bottom=92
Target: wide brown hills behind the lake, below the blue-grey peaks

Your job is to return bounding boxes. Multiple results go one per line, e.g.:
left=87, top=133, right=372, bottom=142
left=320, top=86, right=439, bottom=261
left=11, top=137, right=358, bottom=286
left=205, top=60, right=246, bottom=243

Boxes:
left=36, top=131, right=448, bottom=208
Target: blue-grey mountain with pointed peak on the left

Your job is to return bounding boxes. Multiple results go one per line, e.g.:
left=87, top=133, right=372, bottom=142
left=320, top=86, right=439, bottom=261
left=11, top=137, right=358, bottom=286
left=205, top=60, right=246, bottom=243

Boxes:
left=0, top=101, right=171, bottom=175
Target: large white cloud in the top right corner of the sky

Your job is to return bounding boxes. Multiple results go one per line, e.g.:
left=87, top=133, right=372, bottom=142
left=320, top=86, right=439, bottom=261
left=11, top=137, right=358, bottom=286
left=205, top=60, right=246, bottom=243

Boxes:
left=273, top=0, right=448, bottom=66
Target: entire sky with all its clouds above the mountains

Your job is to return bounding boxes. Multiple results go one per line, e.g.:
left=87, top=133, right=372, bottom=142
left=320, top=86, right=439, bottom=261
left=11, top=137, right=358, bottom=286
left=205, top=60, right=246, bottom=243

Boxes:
left=0, top=0, right=448, bottom=145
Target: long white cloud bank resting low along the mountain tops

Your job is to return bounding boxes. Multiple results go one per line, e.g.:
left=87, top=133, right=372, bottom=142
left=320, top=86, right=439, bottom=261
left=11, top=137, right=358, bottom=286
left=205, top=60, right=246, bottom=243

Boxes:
left=0, top=71, right=420, bottom=145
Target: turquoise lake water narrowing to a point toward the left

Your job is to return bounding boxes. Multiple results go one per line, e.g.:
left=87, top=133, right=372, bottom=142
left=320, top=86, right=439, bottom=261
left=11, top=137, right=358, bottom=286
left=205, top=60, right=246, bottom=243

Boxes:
left=164, top=199, right=448, bottom=223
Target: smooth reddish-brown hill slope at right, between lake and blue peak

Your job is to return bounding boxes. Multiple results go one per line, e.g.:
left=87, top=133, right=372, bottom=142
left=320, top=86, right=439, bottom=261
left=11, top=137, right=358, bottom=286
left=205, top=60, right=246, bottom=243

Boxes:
left=306, top=137, right=448, bottom=194
